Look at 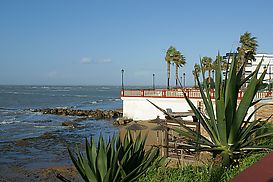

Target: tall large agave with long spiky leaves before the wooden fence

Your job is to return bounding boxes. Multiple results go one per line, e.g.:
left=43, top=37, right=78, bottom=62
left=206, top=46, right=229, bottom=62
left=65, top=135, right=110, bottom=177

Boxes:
left=149, top=54, right=273, bottom=166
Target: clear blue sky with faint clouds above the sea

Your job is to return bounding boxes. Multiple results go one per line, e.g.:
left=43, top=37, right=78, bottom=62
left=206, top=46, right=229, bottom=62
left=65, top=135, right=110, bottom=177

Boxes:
left=0, top=0, right=273, bottom=86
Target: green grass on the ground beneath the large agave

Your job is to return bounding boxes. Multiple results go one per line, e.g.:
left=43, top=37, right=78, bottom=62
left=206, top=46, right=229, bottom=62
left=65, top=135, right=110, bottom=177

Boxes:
left=138, top=152, right=267, bottom=182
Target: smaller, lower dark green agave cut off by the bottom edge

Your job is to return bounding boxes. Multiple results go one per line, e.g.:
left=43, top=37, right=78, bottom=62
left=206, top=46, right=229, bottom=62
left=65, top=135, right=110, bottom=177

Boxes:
left=68, top=131, right=164, bottom=182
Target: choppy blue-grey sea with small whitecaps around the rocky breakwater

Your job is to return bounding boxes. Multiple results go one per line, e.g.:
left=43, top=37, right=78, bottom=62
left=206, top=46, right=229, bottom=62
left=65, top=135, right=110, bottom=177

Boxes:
left=0, top=85, right=122, bottom=173
